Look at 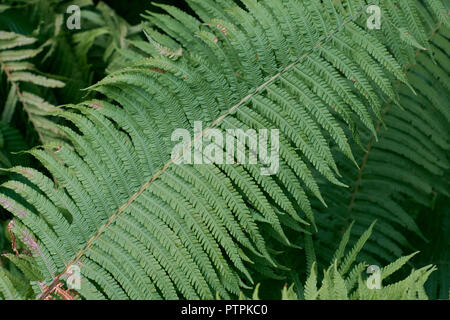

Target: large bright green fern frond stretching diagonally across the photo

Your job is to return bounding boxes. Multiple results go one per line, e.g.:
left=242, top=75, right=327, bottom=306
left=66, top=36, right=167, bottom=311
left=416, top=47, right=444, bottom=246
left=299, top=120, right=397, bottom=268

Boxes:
left=0, top=0, right=448, bottom=299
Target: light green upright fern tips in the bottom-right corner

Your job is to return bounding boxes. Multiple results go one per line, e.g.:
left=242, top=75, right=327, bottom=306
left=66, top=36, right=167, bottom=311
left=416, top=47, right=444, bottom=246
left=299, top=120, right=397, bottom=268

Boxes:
left=253, top=227, right=436, bottom=300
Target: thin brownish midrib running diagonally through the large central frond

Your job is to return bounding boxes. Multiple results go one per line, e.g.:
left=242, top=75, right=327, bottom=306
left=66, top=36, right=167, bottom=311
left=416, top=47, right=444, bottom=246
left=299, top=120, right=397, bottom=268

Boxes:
left=38, top=6, right=368, bottom=300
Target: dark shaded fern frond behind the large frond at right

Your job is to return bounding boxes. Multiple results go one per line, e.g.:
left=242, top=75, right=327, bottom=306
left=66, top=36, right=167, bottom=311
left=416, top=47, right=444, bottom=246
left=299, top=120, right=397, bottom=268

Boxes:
left=302, top=25, right=450, bottom=296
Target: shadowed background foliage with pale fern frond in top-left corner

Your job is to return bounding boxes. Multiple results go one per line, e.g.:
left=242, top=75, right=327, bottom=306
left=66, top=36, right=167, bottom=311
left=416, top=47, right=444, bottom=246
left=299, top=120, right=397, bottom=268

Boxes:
left=0, top=0, right=139, bottom=162
